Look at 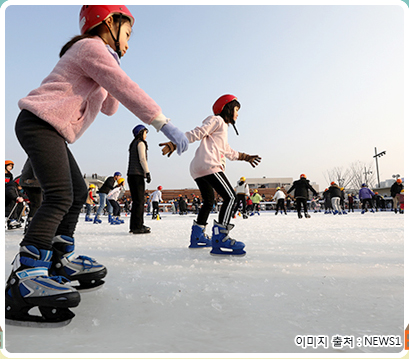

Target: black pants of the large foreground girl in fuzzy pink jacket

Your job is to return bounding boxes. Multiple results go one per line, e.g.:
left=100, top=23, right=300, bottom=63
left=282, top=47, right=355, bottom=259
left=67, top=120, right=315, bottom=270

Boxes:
left=15, top=110, right=87, bottom=250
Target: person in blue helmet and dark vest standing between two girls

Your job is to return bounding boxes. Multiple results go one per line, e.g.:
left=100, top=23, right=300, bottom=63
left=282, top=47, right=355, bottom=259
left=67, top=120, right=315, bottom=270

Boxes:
left=127, top=125, right=151, bottom=234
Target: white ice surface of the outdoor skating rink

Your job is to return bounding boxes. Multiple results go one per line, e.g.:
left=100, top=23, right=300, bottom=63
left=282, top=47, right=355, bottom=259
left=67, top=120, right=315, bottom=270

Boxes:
left=4, top=211, right=405, bottom=357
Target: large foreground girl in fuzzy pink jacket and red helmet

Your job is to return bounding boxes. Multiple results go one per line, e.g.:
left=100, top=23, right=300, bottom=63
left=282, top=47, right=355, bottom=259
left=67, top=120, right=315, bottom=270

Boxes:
left=6, top=5, right=188, bottom=326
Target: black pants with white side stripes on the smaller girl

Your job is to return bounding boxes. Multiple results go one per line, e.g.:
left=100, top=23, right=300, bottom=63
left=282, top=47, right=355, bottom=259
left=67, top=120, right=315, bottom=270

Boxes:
left=195, top=172, right=236, bottom=226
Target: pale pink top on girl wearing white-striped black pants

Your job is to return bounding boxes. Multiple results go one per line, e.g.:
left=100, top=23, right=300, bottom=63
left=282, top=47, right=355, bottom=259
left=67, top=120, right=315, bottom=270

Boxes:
left=185, top=116, right=239, bottom=179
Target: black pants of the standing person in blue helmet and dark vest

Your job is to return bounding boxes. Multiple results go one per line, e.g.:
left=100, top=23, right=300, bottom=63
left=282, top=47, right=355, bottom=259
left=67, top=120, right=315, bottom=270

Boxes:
left=128, top=175, right=145, bottom=231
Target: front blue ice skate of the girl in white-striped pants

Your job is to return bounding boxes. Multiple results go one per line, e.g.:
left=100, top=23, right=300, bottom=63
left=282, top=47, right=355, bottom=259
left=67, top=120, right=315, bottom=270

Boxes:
left=210, top=221, right=246, bottom=256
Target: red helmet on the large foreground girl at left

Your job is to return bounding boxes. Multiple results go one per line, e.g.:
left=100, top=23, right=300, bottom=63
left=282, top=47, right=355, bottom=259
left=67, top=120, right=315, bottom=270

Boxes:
left=80, top=5, right=135, bottom=35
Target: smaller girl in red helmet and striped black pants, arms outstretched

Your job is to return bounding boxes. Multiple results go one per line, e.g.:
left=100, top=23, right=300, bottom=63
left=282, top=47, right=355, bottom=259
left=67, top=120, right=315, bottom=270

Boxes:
left=161, top=95, right=261, bottom=256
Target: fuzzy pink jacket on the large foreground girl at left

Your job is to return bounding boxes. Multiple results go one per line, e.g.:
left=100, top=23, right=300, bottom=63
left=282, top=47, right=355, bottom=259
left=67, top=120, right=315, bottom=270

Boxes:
left=18, top=37, right=168, bottom=143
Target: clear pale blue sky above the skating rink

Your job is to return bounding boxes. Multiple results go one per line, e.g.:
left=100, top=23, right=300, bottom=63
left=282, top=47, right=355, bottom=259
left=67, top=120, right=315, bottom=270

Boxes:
left=1, top=1, right=408, bottom=190
